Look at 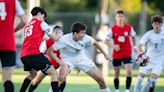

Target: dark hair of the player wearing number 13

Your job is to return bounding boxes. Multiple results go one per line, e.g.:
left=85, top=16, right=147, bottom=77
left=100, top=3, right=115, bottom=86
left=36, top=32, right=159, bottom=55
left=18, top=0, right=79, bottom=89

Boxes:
left=31, top=7, right=47, bottom=18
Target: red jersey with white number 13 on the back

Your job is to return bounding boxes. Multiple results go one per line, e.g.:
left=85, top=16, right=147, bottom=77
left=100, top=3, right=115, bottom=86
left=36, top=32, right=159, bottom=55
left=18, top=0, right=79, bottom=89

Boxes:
left=20, top=18, right=44, bottom=57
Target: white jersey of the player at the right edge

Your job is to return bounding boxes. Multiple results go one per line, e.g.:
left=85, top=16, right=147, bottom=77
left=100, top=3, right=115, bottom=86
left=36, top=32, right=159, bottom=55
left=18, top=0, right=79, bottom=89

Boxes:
left=140, top=30, right=164, bottom=63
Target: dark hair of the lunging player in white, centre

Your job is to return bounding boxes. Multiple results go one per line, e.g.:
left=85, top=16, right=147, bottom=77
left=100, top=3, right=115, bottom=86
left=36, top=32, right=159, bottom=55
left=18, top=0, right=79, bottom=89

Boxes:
left=71, top=22, right=87, bottom=34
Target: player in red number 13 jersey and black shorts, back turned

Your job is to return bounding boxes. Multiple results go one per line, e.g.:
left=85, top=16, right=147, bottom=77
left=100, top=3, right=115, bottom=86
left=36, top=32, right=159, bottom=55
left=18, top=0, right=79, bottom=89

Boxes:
left=20, top=7, right=64, bottom=92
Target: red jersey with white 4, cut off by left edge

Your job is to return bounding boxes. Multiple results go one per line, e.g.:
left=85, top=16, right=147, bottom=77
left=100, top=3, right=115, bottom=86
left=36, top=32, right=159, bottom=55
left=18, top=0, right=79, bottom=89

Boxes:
left=0, top=0, right=16, bottom=51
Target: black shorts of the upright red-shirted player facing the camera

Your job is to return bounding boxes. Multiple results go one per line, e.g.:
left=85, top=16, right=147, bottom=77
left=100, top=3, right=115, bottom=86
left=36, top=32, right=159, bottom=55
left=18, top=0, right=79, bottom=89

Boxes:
left=112, top=57, right=132, bottom=67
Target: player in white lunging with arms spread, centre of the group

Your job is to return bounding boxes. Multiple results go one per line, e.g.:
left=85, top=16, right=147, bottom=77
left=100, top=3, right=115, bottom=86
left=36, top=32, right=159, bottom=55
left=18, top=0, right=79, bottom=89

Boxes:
left=47, top=22, right=110, bottom=92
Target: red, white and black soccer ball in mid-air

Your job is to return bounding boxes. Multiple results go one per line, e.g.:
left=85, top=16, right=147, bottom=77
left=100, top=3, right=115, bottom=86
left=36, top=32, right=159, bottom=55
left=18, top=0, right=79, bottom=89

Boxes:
left=135, top=53, right=149, bottom=67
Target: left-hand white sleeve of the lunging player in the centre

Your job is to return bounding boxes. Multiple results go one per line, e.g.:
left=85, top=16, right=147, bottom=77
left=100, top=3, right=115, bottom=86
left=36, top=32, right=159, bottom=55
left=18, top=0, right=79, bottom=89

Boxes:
left=52, top=37, right=66, bottom=50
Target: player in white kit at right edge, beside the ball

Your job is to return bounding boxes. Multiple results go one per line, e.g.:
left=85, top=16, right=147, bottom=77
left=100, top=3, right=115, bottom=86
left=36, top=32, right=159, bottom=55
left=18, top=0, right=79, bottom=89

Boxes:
left=134, top=15, right=164, bottom=92
